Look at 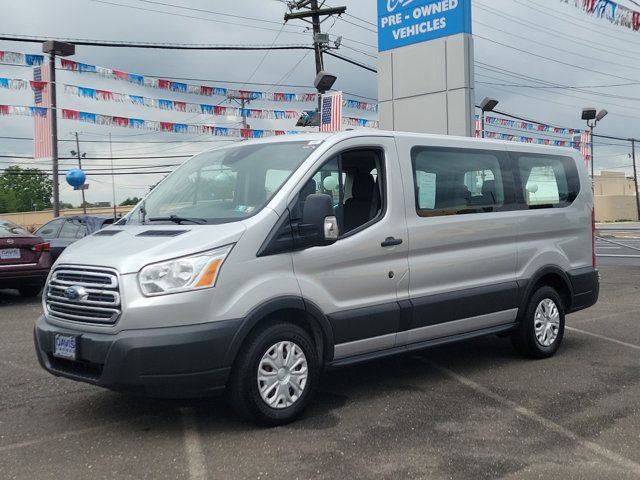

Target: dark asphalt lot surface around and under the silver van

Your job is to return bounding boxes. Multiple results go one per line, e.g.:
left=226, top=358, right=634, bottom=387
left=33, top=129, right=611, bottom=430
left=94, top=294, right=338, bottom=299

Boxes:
left=0, top=266, right=640, bottom=480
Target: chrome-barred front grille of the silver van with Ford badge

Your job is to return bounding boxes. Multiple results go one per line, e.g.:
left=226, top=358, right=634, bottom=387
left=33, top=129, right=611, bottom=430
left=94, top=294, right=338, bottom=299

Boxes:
left=46, top=266, right=121, bottom=325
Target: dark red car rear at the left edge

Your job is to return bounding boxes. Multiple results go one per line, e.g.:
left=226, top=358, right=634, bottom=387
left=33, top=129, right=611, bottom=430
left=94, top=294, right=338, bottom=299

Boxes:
left=0, top=219, right=52, bottom=297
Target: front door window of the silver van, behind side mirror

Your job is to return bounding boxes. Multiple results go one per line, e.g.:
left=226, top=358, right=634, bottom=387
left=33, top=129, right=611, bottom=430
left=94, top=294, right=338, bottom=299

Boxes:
left=297, top=148, right=385, bottom=236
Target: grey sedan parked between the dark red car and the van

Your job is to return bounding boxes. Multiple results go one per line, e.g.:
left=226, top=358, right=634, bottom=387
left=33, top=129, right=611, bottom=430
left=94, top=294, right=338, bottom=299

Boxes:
left=35, top=215, right=113, bottom=262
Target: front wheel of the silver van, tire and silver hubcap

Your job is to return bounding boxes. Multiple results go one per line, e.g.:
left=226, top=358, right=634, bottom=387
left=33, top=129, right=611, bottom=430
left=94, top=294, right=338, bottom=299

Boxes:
left=227, top=322, right=320, bottom=426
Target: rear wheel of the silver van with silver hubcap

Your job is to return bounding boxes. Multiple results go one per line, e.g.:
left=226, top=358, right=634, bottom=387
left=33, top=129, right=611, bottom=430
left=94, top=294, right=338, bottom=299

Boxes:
left=511, top=286, right=564, bottom=358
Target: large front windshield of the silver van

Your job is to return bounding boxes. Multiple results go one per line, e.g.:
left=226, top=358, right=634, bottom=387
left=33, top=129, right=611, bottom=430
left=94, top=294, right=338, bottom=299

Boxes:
left=128, top=141, right=319, bottom=224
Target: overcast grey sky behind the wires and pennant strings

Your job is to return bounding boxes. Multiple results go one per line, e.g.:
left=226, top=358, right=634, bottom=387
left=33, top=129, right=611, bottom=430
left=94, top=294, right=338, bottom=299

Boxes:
left=0, top=0, right=640, bottom=204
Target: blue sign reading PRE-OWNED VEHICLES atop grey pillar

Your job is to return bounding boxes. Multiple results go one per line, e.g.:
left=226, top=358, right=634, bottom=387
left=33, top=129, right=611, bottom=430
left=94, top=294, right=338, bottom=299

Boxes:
left=378, top=0, right=471, bottom=52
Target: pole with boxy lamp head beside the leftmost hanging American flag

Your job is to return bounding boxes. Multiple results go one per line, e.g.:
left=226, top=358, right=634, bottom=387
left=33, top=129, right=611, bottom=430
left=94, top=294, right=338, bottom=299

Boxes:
left=42, top=40, right=76, bottom=217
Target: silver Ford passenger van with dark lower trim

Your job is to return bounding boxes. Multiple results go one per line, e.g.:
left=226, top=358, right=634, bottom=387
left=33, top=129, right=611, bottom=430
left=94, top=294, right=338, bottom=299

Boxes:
left=35, top=131, right=599, bottom=425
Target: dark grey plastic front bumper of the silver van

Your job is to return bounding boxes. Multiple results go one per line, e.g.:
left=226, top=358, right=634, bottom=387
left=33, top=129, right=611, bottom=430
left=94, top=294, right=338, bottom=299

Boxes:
left=34, top=316, right=242, bottom=398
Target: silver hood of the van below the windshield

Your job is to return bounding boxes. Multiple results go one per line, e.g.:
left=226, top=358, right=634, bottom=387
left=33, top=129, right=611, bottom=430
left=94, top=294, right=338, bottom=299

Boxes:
left=56, top=221, right=246, bottom=274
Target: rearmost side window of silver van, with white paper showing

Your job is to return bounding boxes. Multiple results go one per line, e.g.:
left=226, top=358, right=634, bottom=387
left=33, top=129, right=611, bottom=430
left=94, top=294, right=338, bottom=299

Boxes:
left=514, top=154, right=580, bottom=208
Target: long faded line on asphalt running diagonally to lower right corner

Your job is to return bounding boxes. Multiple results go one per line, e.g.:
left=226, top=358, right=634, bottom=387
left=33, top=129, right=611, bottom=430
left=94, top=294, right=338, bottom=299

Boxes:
left=420, top=358, right=640, bottom=475
